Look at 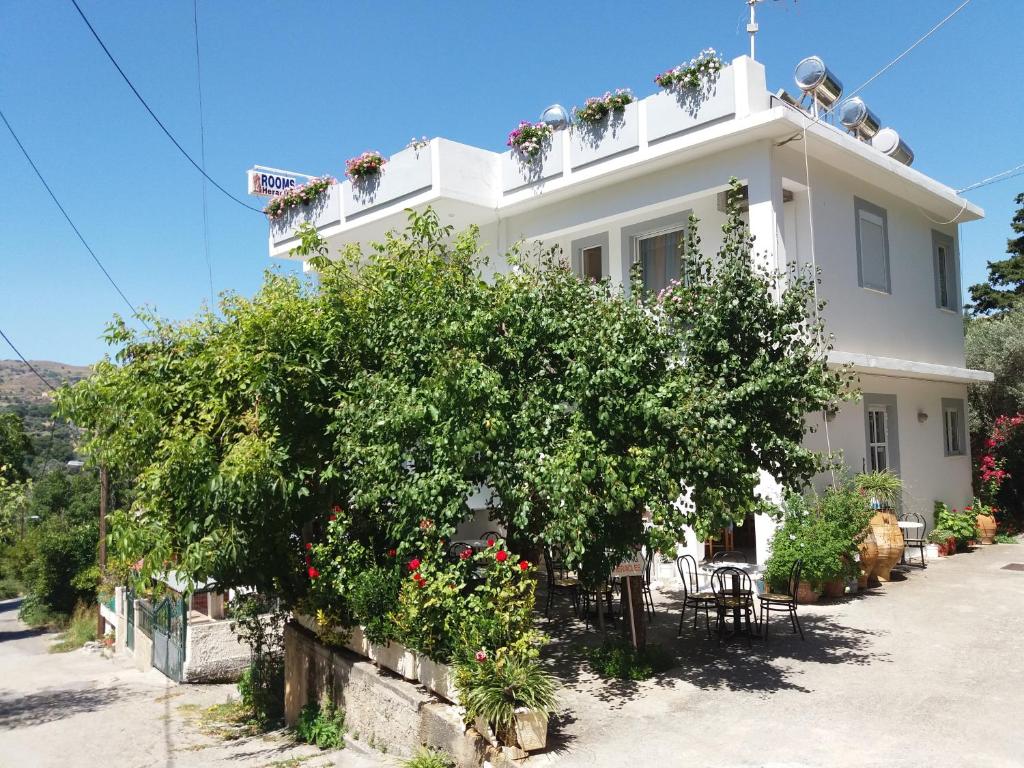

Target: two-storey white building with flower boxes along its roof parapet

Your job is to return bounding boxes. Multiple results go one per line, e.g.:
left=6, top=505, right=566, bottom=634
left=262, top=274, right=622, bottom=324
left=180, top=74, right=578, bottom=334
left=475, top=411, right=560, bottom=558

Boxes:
left=269, top=56, right=991, bottom=560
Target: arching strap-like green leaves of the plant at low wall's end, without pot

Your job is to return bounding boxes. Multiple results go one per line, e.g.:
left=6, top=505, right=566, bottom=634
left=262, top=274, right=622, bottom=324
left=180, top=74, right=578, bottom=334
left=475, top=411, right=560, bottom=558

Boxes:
left=456, top=655, right=555, bottom=743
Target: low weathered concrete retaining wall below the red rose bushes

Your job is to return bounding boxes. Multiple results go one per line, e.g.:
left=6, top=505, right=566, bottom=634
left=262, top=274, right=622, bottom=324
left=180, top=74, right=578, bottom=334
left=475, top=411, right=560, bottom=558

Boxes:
left=285, top=623, right=486, bottom=768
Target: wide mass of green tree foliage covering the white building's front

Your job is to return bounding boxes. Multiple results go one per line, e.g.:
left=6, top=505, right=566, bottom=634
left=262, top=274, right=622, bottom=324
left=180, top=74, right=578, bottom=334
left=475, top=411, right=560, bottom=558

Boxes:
left=58, top=185, right=844, bottom=597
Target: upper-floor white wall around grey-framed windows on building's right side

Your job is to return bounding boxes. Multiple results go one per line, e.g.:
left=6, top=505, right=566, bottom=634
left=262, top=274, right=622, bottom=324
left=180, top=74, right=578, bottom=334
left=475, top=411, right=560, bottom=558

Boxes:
left=776, top=149, right=965, bottom=367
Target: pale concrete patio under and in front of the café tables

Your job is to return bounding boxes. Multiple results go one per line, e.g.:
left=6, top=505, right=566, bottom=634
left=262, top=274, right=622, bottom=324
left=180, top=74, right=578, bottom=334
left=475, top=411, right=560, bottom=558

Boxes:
left=525, top=545, right=1024, bottom=768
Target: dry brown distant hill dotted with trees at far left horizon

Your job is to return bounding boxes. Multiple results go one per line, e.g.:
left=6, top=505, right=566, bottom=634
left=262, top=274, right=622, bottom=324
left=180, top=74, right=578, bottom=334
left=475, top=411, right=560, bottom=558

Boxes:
left=0, top=360, right=92, bottom=473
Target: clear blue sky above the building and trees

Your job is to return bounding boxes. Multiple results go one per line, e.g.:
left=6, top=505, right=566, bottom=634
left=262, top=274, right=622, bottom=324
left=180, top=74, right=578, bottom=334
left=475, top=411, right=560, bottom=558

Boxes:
left=0, top=0, right=1024, bottom=364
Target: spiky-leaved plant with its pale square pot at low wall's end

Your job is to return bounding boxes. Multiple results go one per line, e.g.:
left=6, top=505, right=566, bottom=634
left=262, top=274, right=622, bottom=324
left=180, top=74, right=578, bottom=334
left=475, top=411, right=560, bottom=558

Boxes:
left=456, top=649, right=555, bottom=752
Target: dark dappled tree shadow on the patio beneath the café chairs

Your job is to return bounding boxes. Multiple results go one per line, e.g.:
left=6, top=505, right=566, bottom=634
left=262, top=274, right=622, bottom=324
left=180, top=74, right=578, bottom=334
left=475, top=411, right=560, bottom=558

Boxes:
left=538, top=581, right=890, bottom=709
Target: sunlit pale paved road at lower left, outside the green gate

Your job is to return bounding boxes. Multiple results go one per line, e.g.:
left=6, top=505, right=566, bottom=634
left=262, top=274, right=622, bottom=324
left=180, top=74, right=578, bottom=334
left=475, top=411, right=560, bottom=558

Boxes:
left=0, top=600, right=385, bottom=768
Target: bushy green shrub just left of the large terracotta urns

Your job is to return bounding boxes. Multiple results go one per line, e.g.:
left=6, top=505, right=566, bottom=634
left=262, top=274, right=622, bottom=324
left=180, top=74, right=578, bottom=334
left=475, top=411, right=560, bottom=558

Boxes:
left=765, top=483, right=871, bottom=590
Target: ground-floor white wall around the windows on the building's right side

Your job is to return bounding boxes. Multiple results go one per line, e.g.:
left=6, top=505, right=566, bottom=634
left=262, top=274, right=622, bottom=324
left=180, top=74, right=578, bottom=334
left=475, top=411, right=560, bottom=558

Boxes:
left=805, top=376, right=973, bottom=529
